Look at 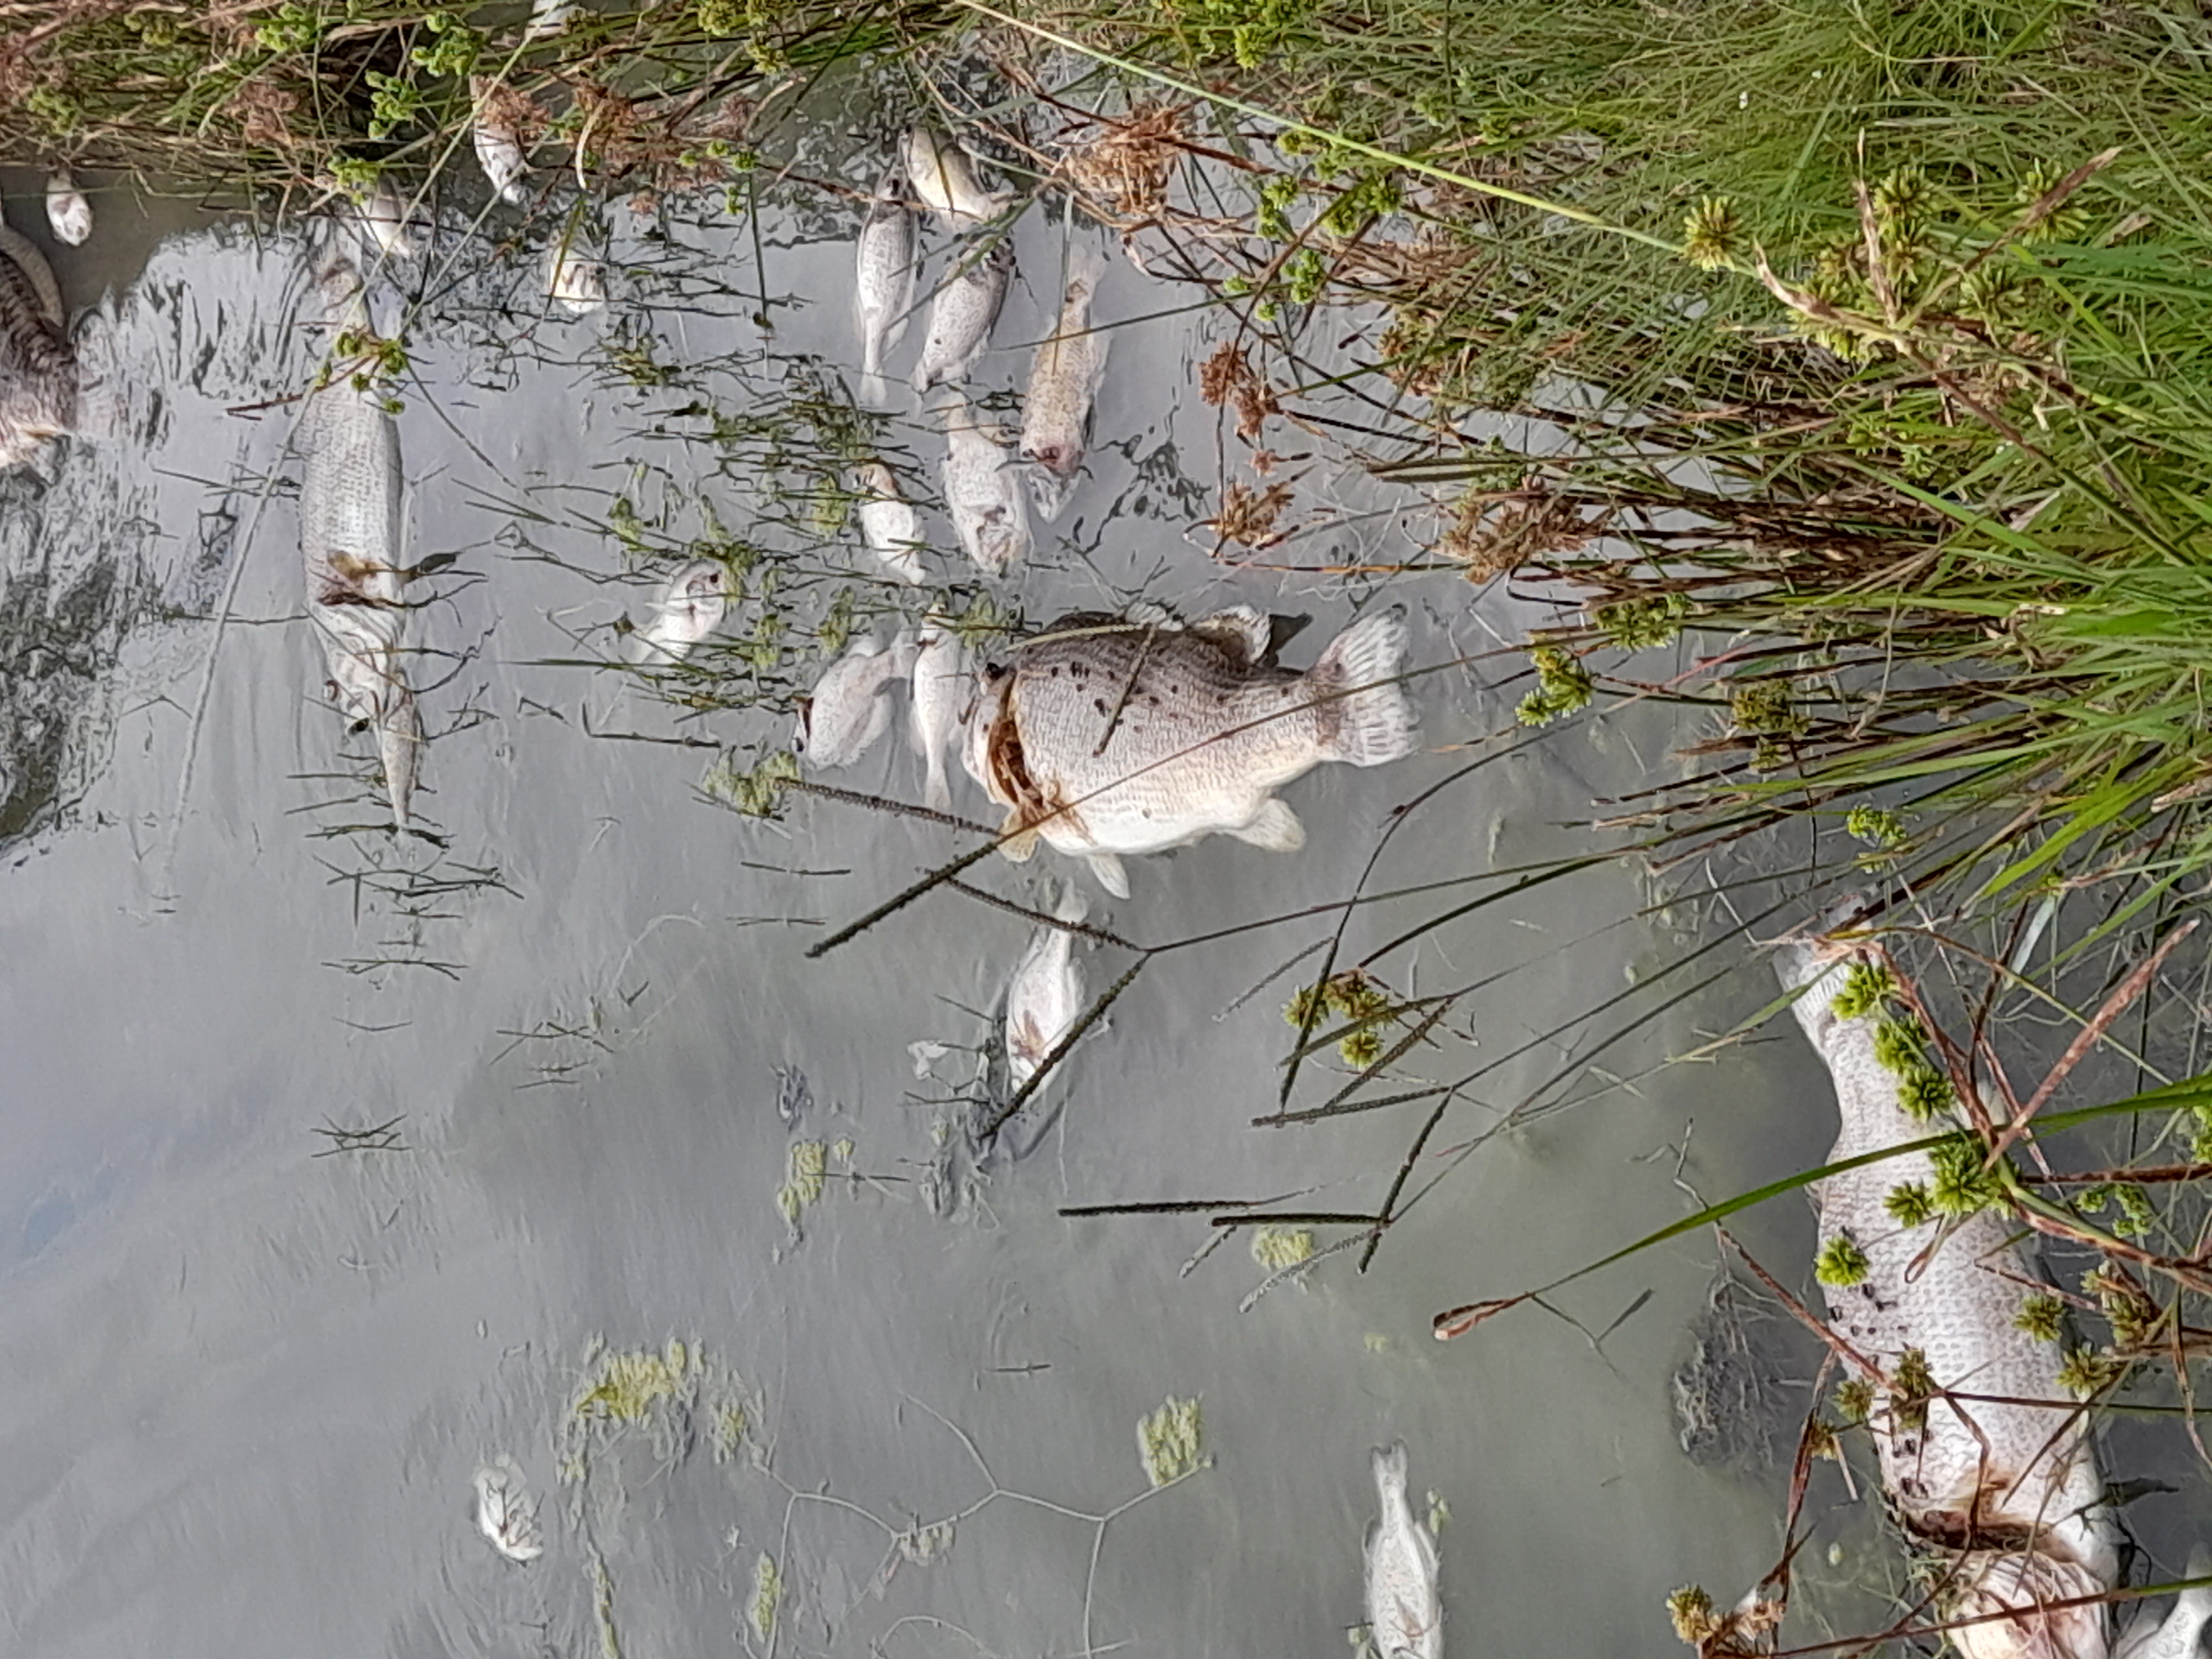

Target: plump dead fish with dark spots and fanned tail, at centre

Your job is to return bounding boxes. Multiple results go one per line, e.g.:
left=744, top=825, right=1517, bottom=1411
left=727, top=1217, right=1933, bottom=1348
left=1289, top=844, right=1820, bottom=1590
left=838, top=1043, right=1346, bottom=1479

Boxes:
left=962, top=606, right=1413, bottom=898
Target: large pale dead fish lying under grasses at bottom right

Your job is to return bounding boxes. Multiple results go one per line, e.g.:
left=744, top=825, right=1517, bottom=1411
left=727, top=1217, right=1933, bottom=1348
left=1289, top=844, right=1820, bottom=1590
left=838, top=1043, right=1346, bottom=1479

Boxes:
left=1776, top=940, right=2119, bottom=1659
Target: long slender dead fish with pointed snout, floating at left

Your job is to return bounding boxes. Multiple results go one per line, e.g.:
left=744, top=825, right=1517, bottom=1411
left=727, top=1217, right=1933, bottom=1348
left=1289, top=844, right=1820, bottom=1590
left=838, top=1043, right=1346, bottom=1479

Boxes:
left=294, top=259, right=422, bottom=830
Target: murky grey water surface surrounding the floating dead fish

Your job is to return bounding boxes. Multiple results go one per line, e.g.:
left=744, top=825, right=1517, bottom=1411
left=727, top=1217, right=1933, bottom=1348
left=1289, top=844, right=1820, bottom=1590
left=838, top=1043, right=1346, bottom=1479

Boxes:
left=0, top=156, right=2194, bottom=1659
